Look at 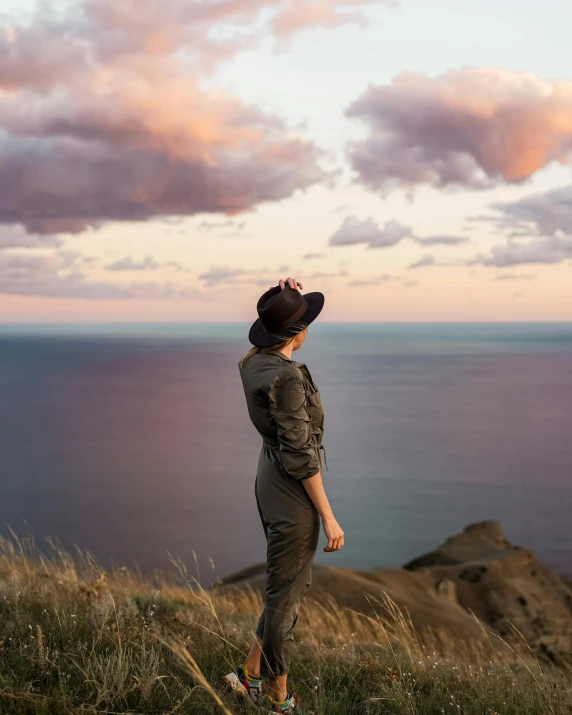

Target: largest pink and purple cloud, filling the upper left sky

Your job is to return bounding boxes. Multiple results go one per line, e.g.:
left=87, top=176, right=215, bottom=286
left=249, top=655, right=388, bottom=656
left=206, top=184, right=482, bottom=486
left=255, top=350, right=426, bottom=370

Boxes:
left=0, top=0, right=394, bottom=234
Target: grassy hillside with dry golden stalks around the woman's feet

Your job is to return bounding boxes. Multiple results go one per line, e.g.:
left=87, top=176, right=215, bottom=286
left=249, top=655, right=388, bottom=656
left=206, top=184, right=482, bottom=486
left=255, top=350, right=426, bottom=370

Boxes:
left=0, top=539, right=572, bottom=715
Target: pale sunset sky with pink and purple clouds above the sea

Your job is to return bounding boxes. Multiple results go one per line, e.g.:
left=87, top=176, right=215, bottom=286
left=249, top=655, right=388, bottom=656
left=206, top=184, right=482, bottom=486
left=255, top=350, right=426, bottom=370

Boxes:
left=0, top=0, right=572, bottom=322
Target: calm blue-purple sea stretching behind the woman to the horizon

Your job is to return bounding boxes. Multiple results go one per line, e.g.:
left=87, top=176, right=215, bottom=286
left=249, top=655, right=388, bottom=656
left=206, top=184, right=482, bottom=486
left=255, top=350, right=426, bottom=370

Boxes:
left=0, top=323, right=572, bottom=582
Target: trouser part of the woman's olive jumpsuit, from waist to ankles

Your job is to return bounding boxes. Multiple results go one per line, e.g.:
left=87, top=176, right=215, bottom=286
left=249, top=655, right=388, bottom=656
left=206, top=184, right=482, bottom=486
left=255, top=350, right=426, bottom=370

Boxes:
left=255, top=449, right=320, bottom=678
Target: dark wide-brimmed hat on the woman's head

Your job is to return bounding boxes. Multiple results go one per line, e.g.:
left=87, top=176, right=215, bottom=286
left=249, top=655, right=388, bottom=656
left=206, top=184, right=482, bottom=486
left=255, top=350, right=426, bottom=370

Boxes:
left=248, top=284, right=324, bottom=348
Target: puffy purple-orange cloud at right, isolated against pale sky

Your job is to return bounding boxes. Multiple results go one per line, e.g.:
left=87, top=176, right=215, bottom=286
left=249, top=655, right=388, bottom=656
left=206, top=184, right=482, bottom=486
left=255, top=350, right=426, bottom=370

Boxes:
left=347, top=67, right=572, bottom=190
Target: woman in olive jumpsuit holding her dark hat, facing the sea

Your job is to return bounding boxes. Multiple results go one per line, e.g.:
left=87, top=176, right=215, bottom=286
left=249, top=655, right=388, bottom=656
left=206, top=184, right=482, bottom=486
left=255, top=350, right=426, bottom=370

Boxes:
left=224, top=278, right=344, bottom=715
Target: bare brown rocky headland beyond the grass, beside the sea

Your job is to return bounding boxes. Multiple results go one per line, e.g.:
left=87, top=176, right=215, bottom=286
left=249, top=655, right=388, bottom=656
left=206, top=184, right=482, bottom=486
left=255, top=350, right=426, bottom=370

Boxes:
left=216, top=521, right=572, bottom=664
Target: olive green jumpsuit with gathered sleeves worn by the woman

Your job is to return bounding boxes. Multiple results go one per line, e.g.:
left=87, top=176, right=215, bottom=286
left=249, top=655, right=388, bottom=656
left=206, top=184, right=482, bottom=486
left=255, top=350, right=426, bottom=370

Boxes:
left=240, top=351, right=324, bottom=678
